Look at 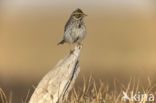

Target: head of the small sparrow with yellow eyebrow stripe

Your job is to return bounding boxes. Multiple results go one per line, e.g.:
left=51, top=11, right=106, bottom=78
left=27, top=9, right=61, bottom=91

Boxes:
left=72, top=8, right=87, bottom=20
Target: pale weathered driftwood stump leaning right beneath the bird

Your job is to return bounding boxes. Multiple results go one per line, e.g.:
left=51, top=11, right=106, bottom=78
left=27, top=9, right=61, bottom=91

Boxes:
left=29, top=46, right=82, bottom=103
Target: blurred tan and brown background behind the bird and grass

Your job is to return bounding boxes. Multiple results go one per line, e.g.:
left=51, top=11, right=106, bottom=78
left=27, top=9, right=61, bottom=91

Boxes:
left=0, top=0, right=156, bottom=103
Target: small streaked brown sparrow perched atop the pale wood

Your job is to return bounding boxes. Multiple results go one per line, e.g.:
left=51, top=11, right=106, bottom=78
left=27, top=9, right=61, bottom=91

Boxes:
left=58, top=8, right=87, bottom=45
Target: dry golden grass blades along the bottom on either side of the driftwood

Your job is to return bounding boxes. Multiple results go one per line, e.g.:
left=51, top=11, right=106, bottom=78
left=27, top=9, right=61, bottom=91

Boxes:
left=0, top=76, right=156, bottom=103
